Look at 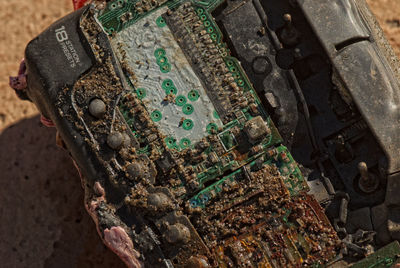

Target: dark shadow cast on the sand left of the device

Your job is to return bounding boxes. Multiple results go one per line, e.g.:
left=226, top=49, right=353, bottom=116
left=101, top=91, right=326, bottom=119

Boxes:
left=0, top=116, right=125, bottom=268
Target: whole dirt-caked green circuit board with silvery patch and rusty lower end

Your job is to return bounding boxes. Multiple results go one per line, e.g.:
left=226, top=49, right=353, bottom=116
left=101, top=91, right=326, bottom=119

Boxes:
left=90, top=0, right=341, bottom=267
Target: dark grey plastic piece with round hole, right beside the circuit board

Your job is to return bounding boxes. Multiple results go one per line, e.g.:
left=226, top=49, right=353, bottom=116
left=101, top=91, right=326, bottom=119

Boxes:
left=222, top=1, right=298, bottom=143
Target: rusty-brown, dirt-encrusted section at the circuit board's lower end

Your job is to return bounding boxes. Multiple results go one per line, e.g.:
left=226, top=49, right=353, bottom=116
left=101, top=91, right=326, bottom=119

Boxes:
left=190, top=166, right=341, bottom=267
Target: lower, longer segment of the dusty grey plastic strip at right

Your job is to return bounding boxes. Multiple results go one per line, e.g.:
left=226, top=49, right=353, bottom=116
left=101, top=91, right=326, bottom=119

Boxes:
left=333, top=41, right=400, bottom=173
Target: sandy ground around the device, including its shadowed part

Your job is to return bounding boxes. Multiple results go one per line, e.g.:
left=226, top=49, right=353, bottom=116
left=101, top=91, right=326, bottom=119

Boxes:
left=0, top=0, right=400, bottom=268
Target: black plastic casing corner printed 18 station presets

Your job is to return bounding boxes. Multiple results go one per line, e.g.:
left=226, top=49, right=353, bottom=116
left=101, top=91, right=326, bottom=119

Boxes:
left=25, top=7, right=102, bottom=184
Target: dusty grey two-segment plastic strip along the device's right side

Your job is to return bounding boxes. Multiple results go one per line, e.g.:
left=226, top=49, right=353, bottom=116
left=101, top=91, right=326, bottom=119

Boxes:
left=298, top=0, right=400, bottom=174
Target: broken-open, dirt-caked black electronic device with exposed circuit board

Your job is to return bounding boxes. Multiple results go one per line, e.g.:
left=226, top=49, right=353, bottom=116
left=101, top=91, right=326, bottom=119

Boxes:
left=18, top=0, right=400, bottom=267
